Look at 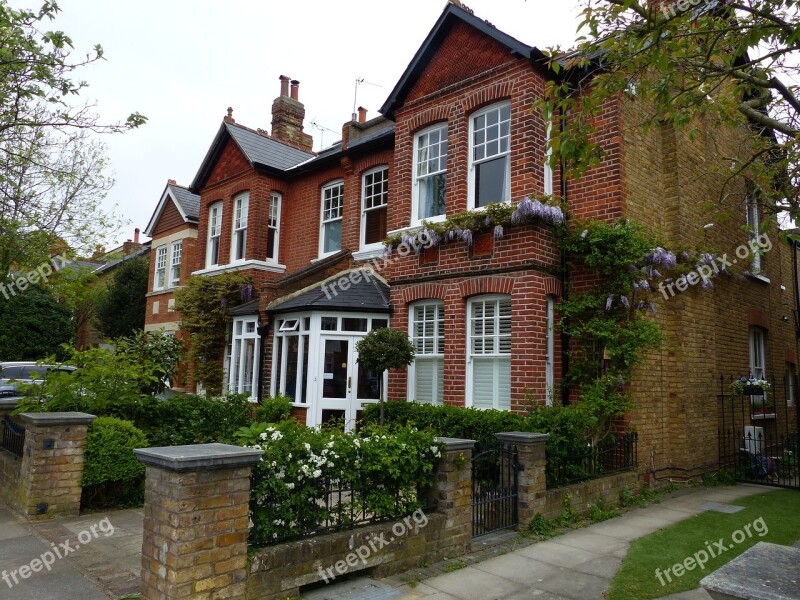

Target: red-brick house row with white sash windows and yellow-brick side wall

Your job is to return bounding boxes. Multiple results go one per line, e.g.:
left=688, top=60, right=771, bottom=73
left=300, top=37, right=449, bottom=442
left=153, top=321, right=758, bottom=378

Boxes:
left=147, top=3, right=798, bottom=479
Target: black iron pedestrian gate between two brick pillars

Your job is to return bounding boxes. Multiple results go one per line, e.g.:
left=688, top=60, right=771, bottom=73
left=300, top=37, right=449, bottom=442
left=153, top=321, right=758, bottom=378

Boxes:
left=472, top=443, right=520, bottom=537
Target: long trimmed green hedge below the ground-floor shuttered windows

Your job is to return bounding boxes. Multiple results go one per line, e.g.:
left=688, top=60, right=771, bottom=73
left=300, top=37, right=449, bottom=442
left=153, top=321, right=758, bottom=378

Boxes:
left=364, top=401, right=595, bottom=482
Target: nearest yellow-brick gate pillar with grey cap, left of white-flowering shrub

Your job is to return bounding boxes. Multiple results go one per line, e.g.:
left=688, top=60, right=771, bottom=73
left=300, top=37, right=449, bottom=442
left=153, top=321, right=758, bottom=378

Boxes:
left=134, top=444, right=263, bottom=600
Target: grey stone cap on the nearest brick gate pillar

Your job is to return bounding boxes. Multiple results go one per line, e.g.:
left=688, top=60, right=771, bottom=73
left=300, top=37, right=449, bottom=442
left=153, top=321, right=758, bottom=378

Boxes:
left=134, top=444, right=264, bottom=471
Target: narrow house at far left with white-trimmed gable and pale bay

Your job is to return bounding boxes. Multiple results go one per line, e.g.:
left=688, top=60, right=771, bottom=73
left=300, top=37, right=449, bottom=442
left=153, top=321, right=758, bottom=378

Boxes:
left=144, top=179, right=200, bottom=391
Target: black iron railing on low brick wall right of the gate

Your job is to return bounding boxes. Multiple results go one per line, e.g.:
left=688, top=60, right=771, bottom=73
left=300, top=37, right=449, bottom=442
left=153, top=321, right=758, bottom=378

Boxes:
left=547, top=432, right=639, bottom=489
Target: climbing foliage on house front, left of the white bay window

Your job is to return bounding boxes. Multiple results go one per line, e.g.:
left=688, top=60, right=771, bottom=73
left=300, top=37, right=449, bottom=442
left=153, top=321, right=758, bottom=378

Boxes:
left=175, top=273, right=254, bottom=395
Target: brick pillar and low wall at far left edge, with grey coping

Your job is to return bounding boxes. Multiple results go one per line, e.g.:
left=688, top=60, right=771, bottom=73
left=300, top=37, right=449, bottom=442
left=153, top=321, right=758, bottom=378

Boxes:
left=0, top=413, right=95, bottom=519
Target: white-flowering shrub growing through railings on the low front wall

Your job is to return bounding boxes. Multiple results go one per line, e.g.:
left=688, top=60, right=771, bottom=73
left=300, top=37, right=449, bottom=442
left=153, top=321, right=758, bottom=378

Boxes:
left=237, top=420, right=441, bottom=545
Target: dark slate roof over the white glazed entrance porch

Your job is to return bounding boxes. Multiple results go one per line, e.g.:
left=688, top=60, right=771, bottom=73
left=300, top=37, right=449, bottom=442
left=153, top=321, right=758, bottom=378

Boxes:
left=267, top=269, right=392, bottom=314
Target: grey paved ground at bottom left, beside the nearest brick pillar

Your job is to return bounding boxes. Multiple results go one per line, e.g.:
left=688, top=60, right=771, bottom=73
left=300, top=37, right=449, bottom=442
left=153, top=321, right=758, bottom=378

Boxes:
left=0, top=505, right=143, bottom=600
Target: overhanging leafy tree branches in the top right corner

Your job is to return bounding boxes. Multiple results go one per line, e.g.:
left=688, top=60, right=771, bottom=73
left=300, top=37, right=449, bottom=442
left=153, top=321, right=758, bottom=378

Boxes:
left=537, top=0, right=800, bottom=217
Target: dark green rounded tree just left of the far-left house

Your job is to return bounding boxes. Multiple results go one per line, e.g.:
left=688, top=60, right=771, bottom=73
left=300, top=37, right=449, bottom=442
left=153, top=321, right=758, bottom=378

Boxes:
left=95, top=258, right=150, bottom=338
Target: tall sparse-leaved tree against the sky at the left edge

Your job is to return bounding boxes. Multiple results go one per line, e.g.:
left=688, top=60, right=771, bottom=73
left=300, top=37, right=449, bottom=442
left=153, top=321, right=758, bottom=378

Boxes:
left=0, top=0, right=146, bottom=283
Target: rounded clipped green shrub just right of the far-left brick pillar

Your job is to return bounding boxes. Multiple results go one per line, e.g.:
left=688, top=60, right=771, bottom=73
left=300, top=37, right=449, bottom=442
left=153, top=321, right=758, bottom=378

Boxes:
left=81, top=417, right=148, bottom=506
